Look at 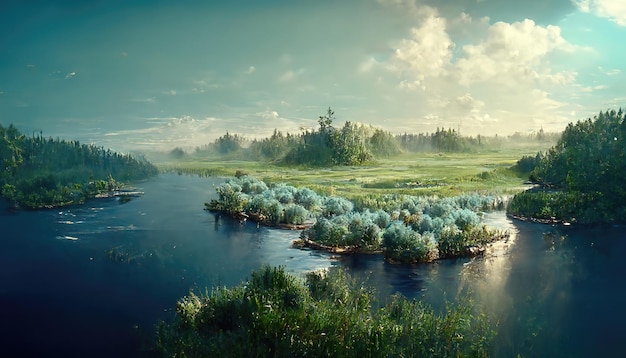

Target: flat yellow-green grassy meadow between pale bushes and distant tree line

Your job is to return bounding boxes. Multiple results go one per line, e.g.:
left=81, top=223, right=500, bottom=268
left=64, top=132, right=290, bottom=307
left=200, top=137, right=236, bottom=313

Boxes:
left=156, top=145, right=546, bottom=198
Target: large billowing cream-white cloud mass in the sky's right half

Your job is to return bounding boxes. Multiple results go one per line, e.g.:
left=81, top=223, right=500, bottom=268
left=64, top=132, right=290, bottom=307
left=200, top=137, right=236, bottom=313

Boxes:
left=358, top=7, right=584, bottom=134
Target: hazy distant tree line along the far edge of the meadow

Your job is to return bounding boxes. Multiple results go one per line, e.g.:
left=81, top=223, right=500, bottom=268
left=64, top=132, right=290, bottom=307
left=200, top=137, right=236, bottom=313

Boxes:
left=178, top=108, right=560, bottom=166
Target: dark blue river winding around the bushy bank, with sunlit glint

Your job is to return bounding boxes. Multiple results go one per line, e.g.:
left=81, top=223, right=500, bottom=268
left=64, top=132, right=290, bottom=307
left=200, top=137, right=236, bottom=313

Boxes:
left=0, top=174, right=626, bottom=357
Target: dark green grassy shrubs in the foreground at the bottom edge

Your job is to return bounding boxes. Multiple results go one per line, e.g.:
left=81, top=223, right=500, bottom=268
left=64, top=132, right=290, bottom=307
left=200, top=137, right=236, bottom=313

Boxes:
left=157, top=266, right=494, bottom=357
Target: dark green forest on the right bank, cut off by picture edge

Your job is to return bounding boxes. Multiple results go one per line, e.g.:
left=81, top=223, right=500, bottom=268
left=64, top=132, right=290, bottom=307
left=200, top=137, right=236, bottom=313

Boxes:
left=508, top=109, right=626, bottom=223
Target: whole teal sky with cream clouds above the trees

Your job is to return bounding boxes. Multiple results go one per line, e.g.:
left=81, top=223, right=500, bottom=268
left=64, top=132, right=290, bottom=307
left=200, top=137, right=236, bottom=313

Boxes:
left=0, top=0, right=626, bottom=151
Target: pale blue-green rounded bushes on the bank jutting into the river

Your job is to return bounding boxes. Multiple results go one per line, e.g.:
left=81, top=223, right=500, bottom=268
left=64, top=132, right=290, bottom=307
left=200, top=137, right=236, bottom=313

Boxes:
left=206, top=175, right=501, bottom=262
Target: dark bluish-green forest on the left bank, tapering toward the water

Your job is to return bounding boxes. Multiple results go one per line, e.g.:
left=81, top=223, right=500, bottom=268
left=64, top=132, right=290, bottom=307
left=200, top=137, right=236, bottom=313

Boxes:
left=0, top=124, right=157, bottom=208
